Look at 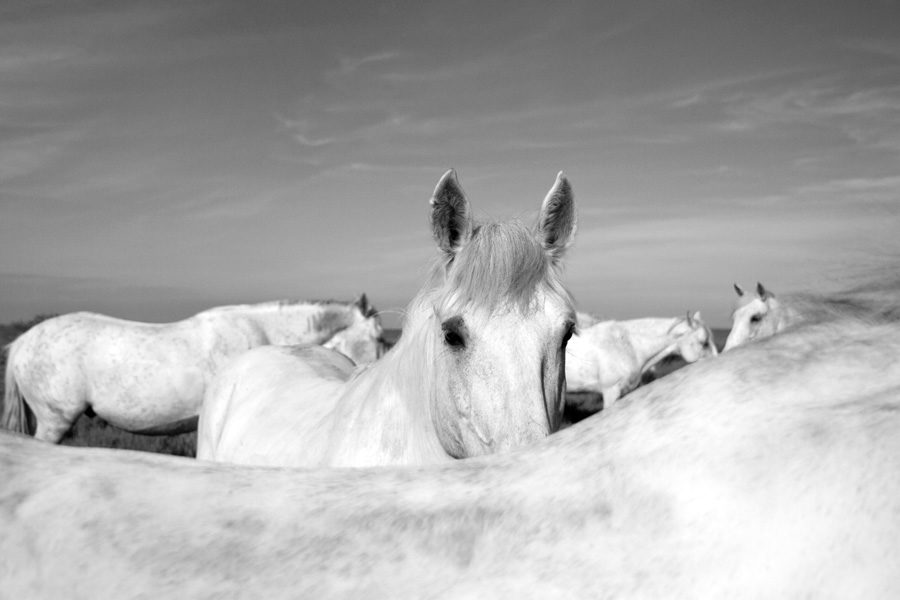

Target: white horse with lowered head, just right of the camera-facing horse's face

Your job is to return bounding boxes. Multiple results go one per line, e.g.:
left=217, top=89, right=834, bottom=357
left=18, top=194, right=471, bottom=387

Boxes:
left=566, top=312, right=718, bottom=413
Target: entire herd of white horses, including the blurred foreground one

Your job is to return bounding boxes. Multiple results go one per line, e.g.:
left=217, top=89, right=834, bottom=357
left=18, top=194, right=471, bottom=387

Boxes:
left=0, top=171, right=900, bottom=598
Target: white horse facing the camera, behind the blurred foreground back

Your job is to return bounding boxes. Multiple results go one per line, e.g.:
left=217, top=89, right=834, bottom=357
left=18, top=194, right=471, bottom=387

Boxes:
left=197, top=170, right=575, bottom=466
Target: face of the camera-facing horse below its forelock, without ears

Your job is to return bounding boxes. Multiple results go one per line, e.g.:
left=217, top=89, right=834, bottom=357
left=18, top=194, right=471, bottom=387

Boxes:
left=431, top=293, right=575, bottom=458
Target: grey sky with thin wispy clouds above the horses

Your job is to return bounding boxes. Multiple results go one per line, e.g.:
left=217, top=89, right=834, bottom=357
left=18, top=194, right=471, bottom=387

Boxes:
left=0, top=0, right=900, bottom=326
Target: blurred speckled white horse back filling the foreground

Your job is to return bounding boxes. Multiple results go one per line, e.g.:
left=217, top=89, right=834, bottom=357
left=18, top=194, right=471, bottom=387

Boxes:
left=0, top=278, right=900, bottom=600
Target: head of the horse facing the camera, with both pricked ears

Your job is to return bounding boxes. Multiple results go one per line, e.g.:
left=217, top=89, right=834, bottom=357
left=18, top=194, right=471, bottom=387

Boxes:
left=424, top=171, right=575, bottom=458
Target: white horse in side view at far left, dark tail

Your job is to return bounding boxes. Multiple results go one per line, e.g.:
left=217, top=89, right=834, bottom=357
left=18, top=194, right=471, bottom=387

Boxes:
left=3, top=295, right=381, bottom=442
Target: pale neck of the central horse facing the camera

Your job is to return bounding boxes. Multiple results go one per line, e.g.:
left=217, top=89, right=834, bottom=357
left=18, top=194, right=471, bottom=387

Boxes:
left=327, top=302, right=451, bottom=466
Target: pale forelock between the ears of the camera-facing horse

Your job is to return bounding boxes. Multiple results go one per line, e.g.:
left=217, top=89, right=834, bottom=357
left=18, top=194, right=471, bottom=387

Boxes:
left=432, top=221, right=574, bottom=314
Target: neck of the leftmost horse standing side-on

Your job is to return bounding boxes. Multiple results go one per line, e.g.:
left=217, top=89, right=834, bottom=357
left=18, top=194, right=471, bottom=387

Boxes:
left=242, top=302, right=353, bottom=344
